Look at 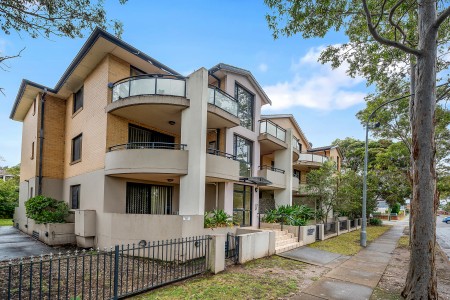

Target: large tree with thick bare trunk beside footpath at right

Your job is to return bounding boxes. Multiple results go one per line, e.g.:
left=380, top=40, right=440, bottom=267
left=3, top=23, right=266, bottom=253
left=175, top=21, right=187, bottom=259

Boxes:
left=265, top=0, right=450, bottom=299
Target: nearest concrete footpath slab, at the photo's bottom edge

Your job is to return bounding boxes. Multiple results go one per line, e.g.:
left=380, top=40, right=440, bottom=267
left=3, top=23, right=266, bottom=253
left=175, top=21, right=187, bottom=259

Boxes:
left=306, top=278, right=372, bottom=300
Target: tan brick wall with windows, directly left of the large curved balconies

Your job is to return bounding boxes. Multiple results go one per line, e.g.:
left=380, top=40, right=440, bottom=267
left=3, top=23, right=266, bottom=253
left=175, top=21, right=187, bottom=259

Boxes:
left=64, top=56, right=109, bottom=178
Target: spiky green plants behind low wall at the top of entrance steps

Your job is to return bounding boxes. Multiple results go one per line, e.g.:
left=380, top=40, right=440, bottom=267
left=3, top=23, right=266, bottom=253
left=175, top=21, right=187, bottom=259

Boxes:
left=262, top=205, right=315, bottom=226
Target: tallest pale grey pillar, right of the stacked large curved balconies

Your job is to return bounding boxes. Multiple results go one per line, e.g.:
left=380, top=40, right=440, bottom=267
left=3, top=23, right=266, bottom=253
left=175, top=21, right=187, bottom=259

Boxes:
left=179, top=68, right=208, bottom=215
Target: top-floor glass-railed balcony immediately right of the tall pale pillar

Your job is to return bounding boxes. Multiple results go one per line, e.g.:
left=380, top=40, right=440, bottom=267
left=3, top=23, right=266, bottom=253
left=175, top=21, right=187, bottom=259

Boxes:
left=208, top=86, right=240, bottom=128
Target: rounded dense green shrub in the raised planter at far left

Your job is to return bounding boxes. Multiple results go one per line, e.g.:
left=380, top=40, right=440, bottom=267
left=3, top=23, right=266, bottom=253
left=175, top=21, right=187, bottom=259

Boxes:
left=25, top=196, right=69, bottom=224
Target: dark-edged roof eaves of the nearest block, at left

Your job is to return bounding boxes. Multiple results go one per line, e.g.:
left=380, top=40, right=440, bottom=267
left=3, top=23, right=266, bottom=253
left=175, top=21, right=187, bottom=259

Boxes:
left=9, top=27, right=180, bottom=121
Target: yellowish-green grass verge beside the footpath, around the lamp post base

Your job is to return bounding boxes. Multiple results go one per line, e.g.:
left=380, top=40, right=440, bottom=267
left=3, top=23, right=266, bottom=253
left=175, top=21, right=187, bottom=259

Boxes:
left=308, top=226, right=391, bottom=255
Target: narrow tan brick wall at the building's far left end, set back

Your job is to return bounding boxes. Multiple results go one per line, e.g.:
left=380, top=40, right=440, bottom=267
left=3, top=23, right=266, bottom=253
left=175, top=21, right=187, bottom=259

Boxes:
left=20, top=95, right=40, bottom=181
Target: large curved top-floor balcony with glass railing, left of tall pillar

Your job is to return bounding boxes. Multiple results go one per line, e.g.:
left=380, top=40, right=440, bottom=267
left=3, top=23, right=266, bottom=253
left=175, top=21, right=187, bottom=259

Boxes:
left=105, top=74, right=189, bottom=131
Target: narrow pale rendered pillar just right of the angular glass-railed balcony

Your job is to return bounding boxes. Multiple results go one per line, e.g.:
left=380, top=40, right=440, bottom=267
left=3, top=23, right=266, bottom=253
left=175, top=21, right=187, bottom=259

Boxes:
left=274, top=128, right=294, bottom=206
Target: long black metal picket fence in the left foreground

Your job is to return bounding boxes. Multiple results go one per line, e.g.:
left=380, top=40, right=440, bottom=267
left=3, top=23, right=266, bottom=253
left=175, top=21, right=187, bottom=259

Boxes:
left=0, top=236, right=211, bottom=300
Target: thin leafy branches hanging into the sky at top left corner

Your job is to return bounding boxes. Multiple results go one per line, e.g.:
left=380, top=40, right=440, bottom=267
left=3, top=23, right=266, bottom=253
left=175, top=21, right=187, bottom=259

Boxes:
left=0, top=0, right=127, bottom=91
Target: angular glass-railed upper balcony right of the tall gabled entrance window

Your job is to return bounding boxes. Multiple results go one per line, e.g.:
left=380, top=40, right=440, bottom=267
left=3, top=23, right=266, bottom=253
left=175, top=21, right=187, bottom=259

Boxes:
left=258, top=120, right=288, bottom=155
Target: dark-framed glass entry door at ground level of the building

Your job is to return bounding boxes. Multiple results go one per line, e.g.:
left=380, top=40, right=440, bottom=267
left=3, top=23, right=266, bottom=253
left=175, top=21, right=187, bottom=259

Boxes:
left=233, top=184, right=253, bottom=226
